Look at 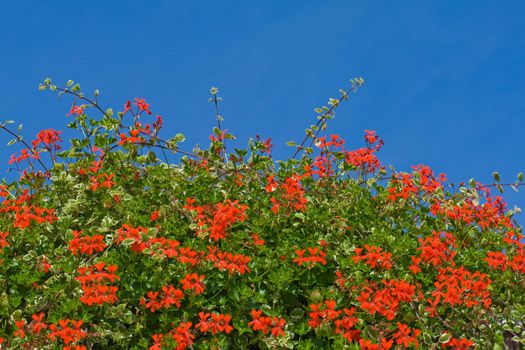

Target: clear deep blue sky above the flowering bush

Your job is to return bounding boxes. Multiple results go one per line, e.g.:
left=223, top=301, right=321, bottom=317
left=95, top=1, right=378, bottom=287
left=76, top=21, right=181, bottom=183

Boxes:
left=0, top=0, right=525, bottom=222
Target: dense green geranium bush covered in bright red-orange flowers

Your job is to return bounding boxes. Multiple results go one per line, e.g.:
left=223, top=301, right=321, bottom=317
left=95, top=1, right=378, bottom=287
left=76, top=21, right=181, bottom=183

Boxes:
left=0, top=78, right=525, bottom=350
